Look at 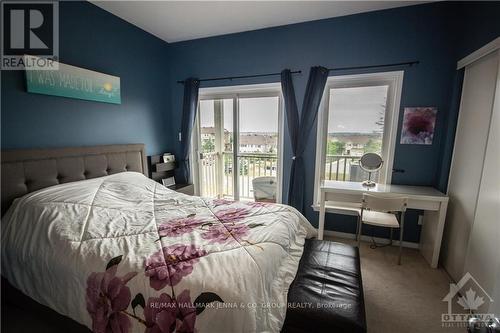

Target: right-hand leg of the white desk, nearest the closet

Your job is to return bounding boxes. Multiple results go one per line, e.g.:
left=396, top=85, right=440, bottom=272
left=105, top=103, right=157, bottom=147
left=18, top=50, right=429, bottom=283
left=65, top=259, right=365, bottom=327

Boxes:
left=420, top=202, right=448, bottom=268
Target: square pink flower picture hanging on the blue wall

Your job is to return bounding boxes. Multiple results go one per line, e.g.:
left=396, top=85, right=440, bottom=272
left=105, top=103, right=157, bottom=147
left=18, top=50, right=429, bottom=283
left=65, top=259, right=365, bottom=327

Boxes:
left=401, top=107, right=437, bottom=145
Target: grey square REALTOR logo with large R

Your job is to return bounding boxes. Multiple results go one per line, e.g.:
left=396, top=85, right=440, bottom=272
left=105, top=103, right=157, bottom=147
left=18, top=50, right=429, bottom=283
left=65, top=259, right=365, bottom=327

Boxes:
left=1, top=1, right=59, bottom=70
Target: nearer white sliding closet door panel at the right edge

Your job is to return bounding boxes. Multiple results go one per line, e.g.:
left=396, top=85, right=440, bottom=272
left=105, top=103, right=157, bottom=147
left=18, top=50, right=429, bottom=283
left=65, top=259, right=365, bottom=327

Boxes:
left=465, top=53, right=500, bottom=313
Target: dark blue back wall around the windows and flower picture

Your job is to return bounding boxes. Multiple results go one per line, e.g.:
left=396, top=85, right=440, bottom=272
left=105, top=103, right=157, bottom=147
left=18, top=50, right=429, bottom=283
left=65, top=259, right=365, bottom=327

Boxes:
left=170, top=3, right=500, bottom=241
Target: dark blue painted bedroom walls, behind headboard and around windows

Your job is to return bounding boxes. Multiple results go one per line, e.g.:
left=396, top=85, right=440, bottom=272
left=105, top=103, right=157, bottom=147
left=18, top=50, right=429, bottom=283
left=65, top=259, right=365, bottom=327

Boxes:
left=1, top=2, right=500, bottom=241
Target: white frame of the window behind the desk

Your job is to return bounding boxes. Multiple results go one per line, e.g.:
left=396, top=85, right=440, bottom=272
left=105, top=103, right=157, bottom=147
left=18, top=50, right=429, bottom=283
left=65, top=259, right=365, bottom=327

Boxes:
left=313, top=71, right=404, bottom=209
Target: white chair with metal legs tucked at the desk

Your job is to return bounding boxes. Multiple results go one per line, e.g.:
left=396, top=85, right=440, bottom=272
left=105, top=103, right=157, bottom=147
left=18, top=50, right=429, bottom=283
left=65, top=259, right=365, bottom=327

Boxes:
left=358, top=193, right=408, bottom=265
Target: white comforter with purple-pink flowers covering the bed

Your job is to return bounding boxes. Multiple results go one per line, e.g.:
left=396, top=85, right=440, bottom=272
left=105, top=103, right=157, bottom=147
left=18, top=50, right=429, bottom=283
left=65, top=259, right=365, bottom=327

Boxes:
left=1, top=172, right=315, bottom=333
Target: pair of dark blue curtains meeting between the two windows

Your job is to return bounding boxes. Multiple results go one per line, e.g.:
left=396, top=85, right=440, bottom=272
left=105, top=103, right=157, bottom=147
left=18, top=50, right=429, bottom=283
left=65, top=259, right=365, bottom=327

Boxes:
left=281, top=66, right=328, bottom=212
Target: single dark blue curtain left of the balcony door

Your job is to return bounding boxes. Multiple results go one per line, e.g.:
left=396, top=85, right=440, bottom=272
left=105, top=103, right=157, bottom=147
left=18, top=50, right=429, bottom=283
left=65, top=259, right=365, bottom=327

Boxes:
left=178, top=78, right=200, bottom=184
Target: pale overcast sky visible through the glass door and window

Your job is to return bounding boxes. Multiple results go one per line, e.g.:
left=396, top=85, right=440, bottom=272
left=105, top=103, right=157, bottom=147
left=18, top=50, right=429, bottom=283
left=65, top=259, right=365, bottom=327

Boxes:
left=200, top=86, right=388, bottom=133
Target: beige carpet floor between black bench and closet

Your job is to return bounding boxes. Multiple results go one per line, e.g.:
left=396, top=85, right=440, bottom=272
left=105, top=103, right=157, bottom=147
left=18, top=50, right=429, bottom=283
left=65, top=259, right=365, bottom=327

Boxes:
left=325, top=237, right=467, bottom=333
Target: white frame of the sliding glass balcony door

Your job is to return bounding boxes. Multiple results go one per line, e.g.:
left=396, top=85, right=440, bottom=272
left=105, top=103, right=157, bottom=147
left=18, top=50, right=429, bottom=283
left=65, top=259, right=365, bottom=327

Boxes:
left=191, top=82, right=285, bottom=203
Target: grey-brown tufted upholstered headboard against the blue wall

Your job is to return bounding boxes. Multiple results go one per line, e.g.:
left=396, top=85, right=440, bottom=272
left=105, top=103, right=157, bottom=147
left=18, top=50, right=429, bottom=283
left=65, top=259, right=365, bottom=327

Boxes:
left=1, top=144, right=148, bottom=216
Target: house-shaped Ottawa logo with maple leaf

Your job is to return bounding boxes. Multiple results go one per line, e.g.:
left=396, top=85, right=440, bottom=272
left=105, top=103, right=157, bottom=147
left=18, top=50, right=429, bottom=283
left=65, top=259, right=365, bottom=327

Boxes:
left=441, top=272, right=495, bottom=327
